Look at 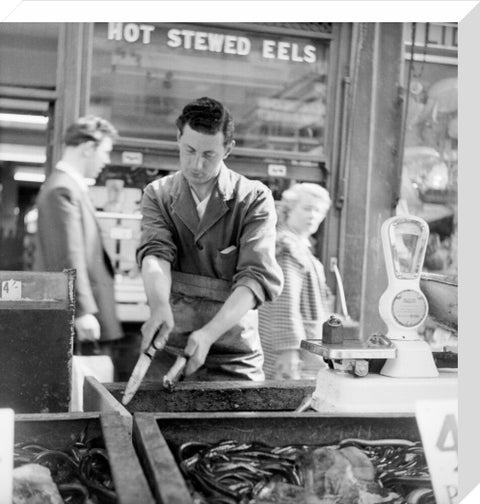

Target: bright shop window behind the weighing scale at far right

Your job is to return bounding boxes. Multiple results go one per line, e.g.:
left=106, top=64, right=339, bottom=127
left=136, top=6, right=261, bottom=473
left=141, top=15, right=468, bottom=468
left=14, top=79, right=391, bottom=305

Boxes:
left=401, top=23, right=458, bottom=275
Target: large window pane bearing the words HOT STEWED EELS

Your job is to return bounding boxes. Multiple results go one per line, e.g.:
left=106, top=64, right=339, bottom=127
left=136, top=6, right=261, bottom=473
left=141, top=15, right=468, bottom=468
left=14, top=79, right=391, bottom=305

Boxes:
left=90, top=23, right=328, bottom=156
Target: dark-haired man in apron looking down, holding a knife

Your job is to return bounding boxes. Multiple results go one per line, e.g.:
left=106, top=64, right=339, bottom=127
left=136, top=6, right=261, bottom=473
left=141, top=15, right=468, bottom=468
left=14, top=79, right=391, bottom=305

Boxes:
left=137, top=98, right=283, bottom=380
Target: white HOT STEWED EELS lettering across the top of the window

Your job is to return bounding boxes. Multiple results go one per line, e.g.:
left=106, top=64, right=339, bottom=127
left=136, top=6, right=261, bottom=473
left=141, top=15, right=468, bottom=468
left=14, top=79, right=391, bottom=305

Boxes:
left=107, top=23, right=317, bottom=63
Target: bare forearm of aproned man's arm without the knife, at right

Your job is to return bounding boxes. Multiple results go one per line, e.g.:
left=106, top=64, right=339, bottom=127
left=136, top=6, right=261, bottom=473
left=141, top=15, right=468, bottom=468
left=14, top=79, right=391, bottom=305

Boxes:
left=203, top=286, right=256, bottom=342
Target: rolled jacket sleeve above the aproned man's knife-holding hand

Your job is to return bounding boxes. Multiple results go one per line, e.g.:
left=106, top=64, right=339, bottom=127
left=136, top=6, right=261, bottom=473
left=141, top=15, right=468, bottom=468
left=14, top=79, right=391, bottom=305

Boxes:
left=136, top=181, right=177, bottom=268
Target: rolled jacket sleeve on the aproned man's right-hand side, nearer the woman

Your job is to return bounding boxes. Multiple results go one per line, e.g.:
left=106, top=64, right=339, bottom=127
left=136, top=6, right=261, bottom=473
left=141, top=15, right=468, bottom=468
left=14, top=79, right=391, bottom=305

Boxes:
left=232, top=186, right=283, bottom=308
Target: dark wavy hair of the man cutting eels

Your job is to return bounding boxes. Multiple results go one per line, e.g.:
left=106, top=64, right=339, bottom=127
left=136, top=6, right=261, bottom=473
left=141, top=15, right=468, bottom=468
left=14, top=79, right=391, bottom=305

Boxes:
left=176, top=96, right=235, bottom=145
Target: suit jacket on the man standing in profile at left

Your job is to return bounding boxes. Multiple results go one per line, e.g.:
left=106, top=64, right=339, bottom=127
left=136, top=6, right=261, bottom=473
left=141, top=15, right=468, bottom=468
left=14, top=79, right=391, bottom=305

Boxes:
left=34, top=169, right=122, bottom=341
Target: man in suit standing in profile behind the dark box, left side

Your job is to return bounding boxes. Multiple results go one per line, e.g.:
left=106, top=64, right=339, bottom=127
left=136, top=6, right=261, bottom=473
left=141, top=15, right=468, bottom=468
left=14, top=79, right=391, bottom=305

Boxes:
left=34, top=116, right=122, bottom=355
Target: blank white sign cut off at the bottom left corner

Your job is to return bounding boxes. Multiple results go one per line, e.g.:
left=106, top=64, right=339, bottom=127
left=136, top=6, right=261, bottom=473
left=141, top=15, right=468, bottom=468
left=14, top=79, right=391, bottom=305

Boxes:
left=0, top=408, right=15, bottom=503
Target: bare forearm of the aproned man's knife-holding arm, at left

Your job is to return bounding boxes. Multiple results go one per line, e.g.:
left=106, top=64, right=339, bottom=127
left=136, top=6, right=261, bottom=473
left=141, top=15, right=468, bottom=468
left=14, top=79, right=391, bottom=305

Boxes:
left=142, top=255, right=172, bottom=310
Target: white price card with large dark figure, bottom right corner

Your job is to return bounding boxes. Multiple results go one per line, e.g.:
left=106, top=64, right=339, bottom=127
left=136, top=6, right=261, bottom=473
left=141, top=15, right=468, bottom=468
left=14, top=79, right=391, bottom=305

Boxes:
left=416, top=400, right=460, bottom=504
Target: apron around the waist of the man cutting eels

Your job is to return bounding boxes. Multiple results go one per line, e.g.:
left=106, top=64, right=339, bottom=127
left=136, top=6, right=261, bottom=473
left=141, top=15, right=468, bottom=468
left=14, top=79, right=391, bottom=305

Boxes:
left=149, top=271, right=265, bottom=381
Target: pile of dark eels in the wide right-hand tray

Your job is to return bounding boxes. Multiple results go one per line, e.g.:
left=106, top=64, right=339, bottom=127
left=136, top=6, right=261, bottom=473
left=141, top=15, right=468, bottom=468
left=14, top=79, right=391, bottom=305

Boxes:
left=178, top=439, right=435, bottom=504
